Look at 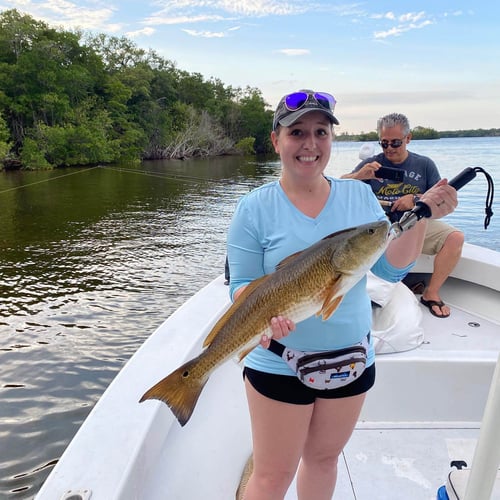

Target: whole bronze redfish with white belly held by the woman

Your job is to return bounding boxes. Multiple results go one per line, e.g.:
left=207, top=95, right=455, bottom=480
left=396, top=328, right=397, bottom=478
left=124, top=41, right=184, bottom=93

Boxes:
left=140, top=220, right=389, bottom=426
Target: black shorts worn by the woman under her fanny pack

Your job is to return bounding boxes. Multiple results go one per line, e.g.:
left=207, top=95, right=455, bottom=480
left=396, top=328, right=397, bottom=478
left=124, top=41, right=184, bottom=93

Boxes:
left=243, top=363, right=375, bottom=405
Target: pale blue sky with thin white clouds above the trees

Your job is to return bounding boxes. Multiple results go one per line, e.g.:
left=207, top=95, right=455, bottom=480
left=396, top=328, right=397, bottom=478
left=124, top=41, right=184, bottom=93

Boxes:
left=0, top=0, right=500, bottom=134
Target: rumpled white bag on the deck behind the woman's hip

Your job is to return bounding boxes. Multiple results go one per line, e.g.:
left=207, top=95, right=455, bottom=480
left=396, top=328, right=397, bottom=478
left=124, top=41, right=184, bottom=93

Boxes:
left=367, top=273, right=424, bottom=354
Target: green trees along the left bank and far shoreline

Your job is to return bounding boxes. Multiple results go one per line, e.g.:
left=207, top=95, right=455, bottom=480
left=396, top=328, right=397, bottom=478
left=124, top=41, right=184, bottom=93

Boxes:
left=0, top=9, right=499, bottom=169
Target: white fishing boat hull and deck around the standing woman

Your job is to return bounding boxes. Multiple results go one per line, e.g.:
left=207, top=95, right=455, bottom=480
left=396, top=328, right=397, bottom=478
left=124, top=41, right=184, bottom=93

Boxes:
left=36, top=243, right=500, bottom=500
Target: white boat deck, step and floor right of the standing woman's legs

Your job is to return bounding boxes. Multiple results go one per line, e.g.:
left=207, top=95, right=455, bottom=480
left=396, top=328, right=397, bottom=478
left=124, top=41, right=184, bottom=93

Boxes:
left=308, top=298, right=500, bottom=500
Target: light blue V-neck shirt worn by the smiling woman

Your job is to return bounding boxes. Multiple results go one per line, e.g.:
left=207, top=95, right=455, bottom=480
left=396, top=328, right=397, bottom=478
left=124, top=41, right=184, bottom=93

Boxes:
left=228, top=177, right=411, bottom=375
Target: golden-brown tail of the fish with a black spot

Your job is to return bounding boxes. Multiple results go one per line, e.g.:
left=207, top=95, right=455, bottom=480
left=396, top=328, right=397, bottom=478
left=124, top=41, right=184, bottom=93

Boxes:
left=139, top=358, right=208, bottom=426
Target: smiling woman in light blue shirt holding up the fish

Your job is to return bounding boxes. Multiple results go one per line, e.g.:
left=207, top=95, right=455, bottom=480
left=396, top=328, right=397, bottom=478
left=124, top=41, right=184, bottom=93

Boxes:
left=228, top=90, right=457, bottom=500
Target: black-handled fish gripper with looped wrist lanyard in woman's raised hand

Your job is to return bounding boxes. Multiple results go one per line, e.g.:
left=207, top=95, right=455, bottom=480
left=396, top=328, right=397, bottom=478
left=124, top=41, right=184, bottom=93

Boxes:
left=391, top=167, right=494, bottom=238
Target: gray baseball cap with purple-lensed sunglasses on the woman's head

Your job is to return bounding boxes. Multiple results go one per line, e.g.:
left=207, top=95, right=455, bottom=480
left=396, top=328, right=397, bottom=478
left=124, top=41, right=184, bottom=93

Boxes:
left=273, top=89, right=339, bottom=130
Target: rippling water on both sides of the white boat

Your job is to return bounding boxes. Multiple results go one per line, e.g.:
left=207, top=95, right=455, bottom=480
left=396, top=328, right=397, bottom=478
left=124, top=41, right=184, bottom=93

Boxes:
left=0, top=138, right=500, bottom=500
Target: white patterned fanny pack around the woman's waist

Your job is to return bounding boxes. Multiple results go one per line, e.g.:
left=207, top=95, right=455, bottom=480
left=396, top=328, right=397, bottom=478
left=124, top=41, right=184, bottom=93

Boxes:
left=269, top=334, right=370, bottom=389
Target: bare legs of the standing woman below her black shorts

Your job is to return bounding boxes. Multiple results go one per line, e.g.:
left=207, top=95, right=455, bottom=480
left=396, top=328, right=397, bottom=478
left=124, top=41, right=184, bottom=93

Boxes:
left=244, top=380, right=365, bottom=500
